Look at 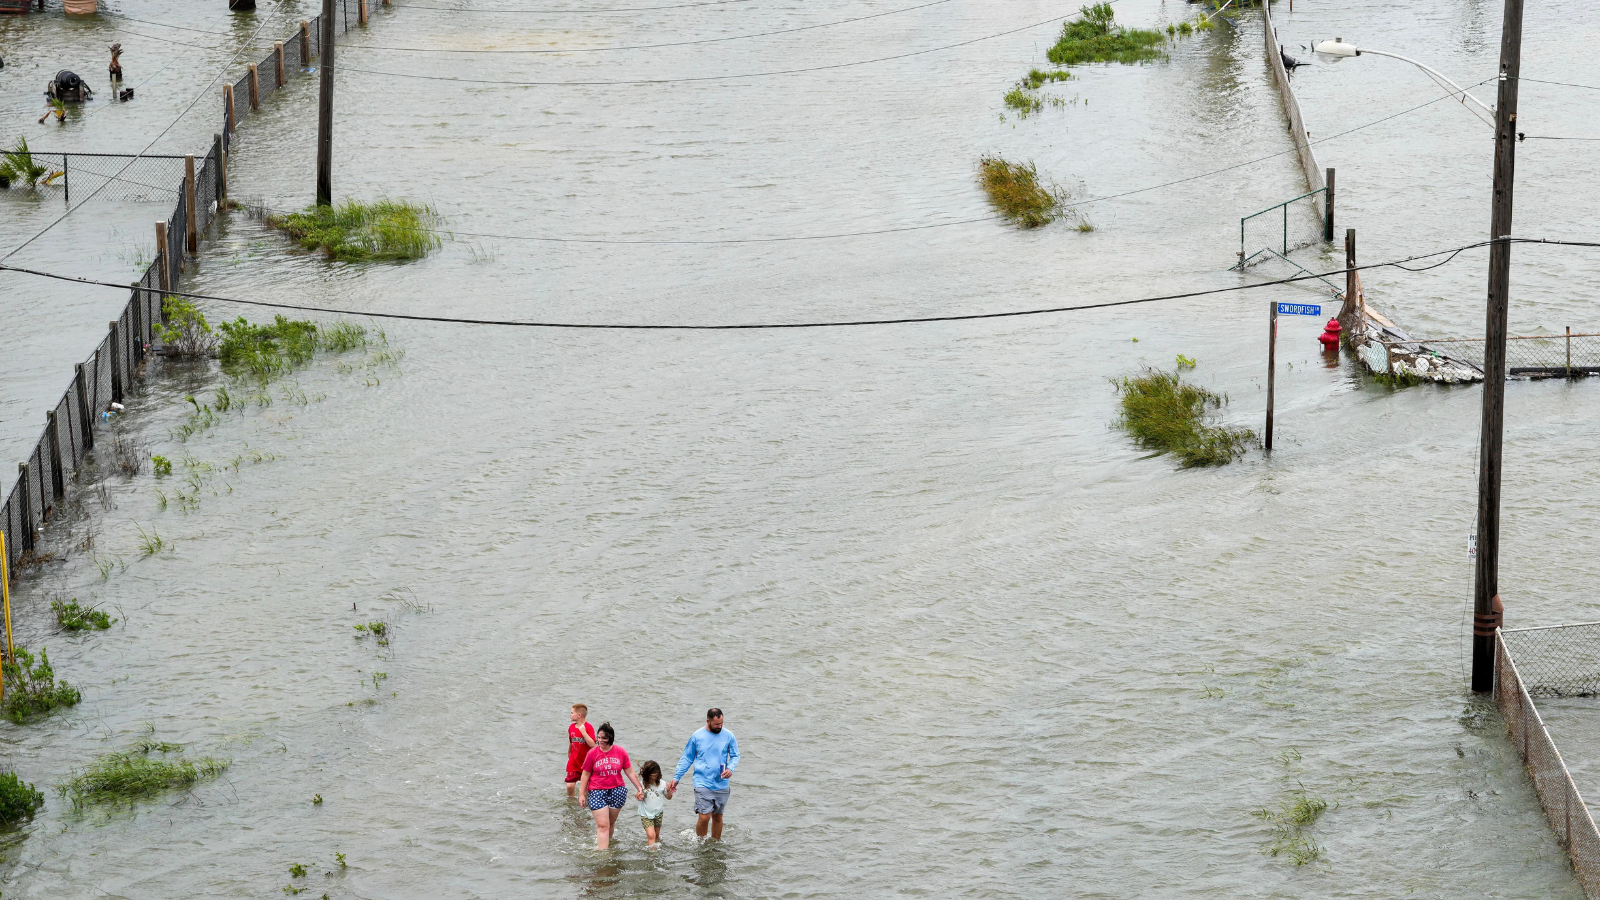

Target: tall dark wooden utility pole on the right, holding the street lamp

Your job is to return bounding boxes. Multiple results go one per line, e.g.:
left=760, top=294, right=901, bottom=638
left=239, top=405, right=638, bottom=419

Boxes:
left=1472, top=0, right=1522, bottom=693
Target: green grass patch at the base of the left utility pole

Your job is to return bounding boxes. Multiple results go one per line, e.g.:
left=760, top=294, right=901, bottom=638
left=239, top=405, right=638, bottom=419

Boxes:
left=266, top=200, right=440, bottom=263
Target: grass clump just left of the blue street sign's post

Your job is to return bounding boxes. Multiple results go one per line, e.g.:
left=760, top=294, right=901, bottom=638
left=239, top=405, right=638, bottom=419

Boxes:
left=1112, top=370, right=1256, bottom=469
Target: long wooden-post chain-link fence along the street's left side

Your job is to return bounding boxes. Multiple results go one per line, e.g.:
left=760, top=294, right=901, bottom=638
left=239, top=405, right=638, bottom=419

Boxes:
left=0, top=0, right=396, bottom=572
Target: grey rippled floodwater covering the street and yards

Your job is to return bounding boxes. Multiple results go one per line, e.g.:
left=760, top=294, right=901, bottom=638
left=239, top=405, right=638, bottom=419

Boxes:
left=0, top=0, right=1600, bottom=898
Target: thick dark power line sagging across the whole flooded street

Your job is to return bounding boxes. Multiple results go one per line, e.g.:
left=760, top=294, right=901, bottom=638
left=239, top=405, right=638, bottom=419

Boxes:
left=0, top=237, right=1561, bottom=331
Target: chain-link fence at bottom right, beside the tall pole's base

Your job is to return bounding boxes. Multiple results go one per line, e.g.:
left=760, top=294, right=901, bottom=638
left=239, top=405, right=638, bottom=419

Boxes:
left=1494, top=623, right=1600, bottom=900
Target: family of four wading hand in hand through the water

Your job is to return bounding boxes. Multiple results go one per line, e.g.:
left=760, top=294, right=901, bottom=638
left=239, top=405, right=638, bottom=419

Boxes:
left=566, top=703, right=739, bottom=850
